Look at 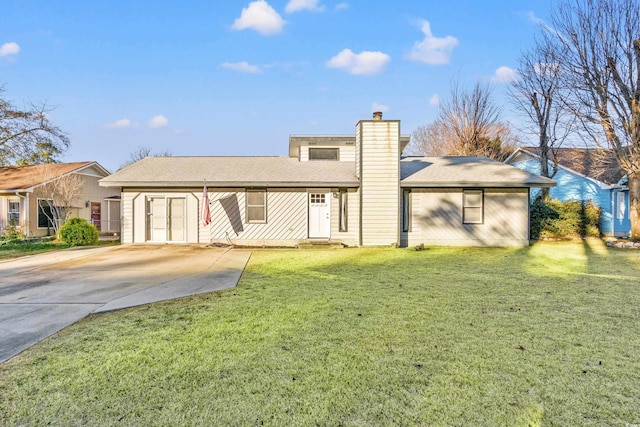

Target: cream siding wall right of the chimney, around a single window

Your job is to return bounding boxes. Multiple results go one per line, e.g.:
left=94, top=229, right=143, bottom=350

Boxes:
left=403, top=188, right=529, bottom=246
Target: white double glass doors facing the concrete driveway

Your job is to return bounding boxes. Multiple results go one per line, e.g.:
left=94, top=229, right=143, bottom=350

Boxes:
left=147, top=196, right=186, bottom=242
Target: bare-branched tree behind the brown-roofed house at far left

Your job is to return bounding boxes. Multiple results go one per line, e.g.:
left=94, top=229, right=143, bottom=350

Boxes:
left=0, top=87, right=70, bottom=165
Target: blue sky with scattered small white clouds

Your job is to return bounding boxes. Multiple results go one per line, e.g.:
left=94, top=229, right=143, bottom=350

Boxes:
left=0, top=0, right=551, bottom=171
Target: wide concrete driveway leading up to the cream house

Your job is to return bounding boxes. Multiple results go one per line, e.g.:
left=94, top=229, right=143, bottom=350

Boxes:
left=0, top=245, right=251, bottom=363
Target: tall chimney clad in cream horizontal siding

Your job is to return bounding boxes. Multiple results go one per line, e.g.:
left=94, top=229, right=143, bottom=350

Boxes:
left=356, top=120, right=400, bottom=246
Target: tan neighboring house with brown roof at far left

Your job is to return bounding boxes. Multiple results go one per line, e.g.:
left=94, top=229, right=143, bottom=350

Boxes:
left=0, top=162, right=120, bottom=236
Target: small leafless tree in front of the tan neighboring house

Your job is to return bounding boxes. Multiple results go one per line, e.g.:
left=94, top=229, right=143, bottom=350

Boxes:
left=34, top=168, right=84, bottom=236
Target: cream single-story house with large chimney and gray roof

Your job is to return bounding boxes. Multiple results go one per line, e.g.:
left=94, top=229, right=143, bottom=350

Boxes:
left=100, top=113, right=555, bottom=246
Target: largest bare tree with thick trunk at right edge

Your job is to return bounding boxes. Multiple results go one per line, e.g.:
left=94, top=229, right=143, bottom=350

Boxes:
left=543, top=0, right=640, bottom=240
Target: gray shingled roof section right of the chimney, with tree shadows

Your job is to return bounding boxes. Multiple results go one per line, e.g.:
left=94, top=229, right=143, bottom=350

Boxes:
left=400, top=156, right=555, bottom=187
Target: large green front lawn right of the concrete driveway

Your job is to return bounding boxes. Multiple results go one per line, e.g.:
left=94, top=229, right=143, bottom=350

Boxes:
left=0, top=241, right=640, bottom=426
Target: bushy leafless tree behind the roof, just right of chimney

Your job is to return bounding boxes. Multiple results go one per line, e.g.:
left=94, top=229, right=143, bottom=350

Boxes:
left=407, top=82, right=517, bottom=160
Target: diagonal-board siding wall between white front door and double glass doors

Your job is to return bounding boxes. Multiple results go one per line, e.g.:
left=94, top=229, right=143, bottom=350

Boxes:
left=200, top=189, right=307, bottom=243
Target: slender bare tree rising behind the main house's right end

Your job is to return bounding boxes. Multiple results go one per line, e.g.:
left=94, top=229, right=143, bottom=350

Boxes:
left=508, top=39, right=575, bottom=198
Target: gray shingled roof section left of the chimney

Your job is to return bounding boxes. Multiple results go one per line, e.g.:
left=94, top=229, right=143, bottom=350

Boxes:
left=100, top=157, right=359, bottom=187
